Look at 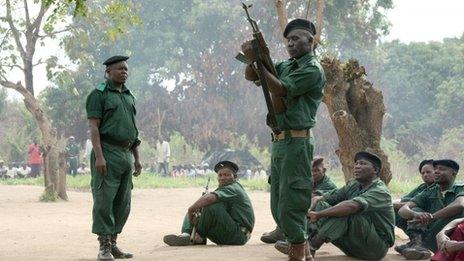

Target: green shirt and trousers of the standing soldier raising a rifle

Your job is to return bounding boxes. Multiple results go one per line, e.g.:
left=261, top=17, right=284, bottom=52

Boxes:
left=269, top=53, right=326, bottom=244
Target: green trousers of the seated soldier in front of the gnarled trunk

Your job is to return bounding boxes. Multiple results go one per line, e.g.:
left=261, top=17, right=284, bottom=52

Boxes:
left=315, top=201, right=389, bottom=260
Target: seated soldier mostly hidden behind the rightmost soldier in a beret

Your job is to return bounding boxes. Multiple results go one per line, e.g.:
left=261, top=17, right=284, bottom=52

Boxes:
left=393, top=160, right=435, bottom=254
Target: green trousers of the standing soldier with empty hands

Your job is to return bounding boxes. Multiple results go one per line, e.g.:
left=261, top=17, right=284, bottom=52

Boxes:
left=90, top=143, right=134, bottom=235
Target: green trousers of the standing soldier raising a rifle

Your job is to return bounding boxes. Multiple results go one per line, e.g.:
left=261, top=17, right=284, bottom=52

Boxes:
left=269, top=135, right=314, bottom=244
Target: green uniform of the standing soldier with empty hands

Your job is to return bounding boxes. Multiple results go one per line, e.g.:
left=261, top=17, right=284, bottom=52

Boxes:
left=86, top=81, right=138, bottom=235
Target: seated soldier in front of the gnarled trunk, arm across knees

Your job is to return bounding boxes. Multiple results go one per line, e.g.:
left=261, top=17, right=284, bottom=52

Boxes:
left=308, top=152, right=395, bottom=260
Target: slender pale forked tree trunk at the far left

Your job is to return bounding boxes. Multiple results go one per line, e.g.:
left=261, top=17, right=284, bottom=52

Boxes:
left=0, top=0, right=68, bottom=200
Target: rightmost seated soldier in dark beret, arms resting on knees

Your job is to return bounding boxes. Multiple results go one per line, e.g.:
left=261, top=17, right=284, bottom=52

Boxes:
left=398, top=159, right=464, bottom=259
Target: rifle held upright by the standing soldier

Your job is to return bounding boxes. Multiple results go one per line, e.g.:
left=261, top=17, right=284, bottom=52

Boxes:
left=235, top=3, right=285, bottom=135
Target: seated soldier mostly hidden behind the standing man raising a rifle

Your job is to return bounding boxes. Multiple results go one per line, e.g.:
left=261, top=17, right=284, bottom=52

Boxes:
left=274, top=156, right=337, bottom=255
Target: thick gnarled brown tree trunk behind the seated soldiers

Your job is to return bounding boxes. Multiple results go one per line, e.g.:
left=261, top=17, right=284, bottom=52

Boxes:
left=277, top=0, right=392, bottom=184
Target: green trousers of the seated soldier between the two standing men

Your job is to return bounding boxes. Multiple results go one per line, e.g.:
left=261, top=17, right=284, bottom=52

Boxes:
left=182, top=202, right=250, bottom=245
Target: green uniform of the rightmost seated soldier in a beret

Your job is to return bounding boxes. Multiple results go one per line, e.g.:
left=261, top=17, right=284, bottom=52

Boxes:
left=408, top=183, right=464, bottom=252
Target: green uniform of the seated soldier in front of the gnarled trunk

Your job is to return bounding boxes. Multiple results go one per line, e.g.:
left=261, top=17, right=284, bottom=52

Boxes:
left=315, top=179, right=395, bottom=260
